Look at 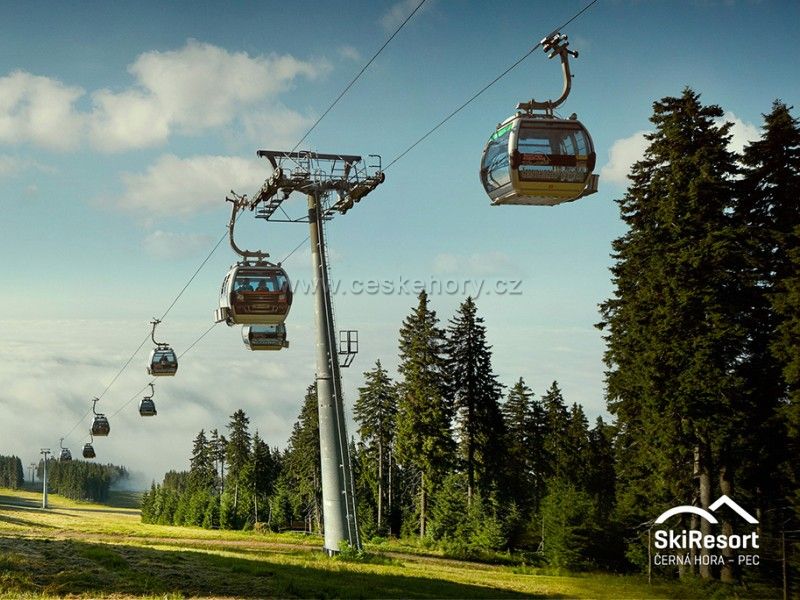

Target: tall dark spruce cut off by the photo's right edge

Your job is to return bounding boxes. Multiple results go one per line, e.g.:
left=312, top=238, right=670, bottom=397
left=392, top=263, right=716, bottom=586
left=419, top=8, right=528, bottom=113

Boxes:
left=738, top=100, right=800, bottom=524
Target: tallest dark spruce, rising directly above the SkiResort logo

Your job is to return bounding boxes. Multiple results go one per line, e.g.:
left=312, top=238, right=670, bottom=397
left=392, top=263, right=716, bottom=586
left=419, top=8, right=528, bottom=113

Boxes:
left=600, top=89, right=748, bottom=577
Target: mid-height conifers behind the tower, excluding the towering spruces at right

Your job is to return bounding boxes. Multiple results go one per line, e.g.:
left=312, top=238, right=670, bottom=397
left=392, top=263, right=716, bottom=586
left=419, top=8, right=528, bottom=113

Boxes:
left=142, top=292, right=614, bottom=566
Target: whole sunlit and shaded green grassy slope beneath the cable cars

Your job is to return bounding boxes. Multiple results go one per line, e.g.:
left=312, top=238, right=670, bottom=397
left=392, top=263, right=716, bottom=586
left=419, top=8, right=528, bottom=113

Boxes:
left=0, top=489, right=769, bottom=599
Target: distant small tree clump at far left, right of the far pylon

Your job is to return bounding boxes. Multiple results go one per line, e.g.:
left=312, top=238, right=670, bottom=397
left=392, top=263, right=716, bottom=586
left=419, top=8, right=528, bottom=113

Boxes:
left=36, top=459, right=128, bottom=502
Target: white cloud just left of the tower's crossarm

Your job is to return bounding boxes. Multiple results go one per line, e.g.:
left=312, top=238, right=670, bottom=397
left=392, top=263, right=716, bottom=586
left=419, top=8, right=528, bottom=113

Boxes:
left=116, top=154, right=269, bottom=216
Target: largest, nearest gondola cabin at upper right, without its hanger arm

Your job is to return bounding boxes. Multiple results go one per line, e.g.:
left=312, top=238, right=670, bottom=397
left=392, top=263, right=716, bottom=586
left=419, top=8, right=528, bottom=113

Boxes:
left=481, top=113, right=599, bottom=206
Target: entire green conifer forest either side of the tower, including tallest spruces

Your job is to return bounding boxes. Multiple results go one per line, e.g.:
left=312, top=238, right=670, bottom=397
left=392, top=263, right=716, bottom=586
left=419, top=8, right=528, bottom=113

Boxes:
left=142, top=88, right=800, bottom=581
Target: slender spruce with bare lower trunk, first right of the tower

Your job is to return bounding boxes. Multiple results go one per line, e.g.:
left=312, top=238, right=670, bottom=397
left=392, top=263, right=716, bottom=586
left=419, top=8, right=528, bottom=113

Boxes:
left=353, top=360, right=397, bottom=533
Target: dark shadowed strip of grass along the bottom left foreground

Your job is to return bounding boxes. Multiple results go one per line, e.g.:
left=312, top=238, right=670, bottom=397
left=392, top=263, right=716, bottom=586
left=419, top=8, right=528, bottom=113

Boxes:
left=0, top=537, right=560, bottom=598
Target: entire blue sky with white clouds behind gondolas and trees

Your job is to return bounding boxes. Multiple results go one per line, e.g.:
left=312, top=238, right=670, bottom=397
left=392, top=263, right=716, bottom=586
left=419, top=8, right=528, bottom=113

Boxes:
left=0, top=0, right=800, bottom=479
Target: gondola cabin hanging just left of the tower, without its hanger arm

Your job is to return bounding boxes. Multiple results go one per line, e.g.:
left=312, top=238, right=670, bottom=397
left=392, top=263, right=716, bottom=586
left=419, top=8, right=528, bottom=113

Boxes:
left=214, top=261, right=292, bottom=325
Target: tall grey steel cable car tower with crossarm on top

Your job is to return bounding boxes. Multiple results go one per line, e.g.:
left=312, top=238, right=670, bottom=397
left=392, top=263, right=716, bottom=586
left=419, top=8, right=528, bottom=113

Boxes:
left=234, top=150, right=385, bottom=554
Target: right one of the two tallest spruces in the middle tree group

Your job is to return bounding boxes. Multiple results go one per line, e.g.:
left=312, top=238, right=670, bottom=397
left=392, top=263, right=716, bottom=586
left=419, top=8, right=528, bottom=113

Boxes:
left=445, top=297, right=504, bottom=504
